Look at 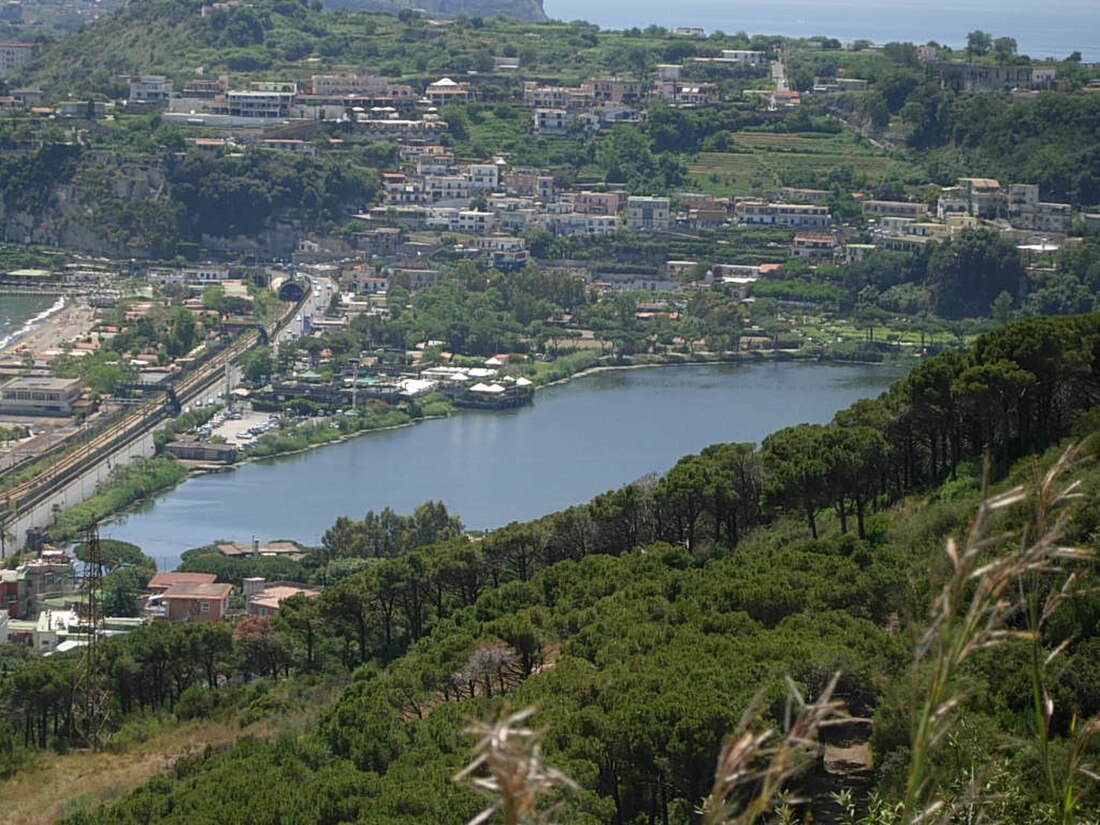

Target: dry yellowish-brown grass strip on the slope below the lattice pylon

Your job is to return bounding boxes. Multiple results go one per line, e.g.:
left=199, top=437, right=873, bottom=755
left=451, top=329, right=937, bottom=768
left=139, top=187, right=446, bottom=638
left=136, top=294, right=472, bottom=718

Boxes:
left=0, top=723, right=272, bottom=825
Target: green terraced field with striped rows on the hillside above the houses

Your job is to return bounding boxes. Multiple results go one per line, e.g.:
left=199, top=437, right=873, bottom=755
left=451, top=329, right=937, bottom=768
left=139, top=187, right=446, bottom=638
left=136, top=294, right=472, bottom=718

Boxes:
left=688, top=132, right=920, bottom=196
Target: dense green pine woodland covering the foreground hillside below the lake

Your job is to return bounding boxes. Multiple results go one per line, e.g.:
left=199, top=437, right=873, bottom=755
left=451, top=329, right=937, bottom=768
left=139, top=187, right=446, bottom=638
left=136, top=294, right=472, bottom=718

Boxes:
left=0, top=316, right=1100, bottom=824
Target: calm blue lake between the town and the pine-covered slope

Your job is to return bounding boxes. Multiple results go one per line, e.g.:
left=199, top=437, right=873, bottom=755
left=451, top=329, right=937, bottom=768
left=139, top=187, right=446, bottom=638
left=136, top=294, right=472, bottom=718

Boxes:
left=100, top=362, right=902, bottom=570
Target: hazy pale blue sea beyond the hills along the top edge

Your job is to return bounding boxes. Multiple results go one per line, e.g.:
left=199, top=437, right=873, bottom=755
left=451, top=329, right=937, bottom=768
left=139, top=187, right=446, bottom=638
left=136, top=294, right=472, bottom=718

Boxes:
left=543, top=0, right=1100, bottom=63
